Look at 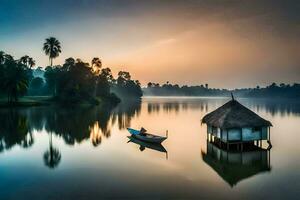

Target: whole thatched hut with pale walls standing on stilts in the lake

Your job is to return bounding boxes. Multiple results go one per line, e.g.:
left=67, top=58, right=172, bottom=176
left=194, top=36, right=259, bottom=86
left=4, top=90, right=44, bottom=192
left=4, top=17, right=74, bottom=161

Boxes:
left=202, top=97, right=272, bottom=148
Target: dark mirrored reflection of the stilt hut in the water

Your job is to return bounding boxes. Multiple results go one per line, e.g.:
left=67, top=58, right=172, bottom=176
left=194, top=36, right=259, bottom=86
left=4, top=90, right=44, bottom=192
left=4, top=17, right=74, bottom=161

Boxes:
left=201, top=142, right=271, bottom=187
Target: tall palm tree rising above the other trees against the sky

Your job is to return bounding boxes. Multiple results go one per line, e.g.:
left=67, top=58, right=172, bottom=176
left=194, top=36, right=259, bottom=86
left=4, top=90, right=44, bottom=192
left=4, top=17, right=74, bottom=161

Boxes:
left=43, top=37, right=61, bottom=66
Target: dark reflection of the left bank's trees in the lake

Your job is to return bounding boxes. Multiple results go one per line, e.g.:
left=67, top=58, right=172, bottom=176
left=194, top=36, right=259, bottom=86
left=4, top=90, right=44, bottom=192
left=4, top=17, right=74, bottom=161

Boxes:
left=0, top=101, right=141, bottom=152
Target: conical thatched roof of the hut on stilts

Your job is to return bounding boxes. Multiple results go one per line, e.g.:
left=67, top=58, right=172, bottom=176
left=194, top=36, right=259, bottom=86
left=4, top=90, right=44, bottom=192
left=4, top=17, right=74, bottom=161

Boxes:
left=202, top=99, right=272, bottom=129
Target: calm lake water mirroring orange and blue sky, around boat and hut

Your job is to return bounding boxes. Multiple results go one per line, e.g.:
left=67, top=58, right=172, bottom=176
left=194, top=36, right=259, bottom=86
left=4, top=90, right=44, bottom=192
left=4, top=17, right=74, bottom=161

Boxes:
left=0, top=97, right=300, bottom=199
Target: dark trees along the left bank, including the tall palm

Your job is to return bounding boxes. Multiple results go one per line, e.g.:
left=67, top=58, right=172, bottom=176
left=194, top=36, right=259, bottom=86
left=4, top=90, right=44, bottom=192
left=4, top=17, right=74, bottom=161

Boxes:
left=0, top=37, right=142, bottom=104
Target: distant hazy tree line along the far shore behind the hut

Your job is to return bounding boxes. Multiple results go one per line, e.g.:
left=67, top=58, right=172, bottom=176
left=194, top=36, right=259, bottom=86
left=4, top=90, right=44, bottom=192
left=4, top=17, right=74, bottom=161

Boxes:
left=143, top=82, right=300, bottom=98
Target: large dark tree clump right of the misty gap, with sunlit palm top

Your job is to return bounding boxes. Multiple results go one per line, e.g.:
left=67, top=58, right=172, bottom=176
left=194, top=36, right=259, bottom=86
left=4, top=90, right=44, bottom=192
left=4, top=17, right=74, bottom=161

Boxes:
left=41, top=58, right=120, bottom=104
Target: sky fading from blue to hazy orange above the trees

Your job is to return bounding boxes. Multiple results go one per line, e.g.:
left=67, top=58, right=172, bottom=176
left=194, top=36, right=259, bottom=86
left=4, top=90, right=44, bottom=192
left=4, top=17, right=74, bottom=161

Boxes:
left=0, top=0, right=300, bottom=88
